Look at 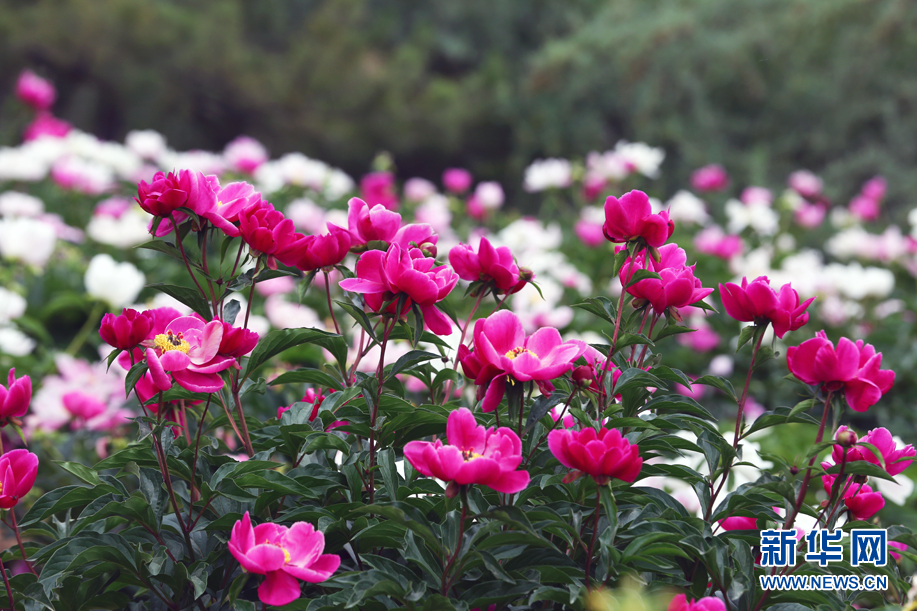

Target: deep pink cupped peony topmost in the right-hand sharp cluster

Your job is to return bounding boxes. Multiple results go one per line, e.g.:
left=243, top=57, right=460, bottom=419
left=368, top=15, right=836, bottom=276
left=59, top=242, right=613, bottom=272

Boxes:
left=603, top=191, right=675, bottom=248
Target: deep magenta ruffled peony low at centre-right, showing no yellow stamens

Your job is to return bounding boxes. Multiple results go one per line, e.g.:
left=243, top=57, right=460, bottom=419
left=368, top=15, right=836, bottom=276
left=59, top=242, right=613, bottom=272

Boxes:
left=548, top=427, right=643, bottom=486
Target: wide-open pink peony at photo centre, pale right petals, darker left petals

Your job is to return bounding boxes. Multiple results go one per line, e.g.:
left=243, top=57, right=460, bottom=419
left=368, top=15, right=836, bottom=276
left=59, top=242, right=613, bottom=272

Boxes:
left=459, top=310, right=586, bottom=412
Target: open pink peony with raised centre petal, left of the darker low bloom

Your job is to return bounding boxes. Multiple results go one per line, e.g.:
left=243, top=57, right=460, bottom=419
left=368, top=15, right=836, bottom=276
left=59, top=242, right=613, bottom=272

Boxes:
left=404, top=407, right=529, bottom=494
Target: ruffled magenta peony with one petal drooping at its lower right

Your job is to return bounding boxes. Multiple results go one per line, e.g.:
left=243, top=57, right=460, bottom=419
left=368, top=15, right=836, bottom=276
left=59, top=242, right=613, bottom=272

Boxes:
left=340, top=244, right=459, bottom=335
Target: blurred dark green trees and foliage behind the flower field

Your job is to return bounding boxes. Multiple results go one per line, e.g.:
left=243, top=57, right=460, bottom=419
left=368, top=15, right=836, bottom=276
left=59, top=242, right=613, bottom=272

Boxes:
left=0, top=0, right=917, bottom=211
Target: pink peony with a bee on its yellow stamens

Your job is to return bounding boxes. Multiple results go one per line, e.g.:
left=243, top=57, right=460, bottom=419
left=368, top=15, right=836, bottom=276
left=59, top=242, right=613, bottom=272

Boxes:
left=144, top=316, right=238, bottom=392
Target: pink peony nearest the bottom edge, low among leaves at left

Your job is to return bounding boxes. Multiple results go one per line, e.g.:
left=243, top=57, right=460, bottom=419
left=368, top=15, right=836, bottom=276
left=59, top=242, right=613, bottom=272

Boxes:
left=229, top=511, right=341, bottom=606
